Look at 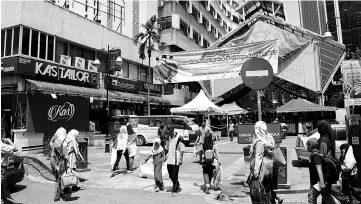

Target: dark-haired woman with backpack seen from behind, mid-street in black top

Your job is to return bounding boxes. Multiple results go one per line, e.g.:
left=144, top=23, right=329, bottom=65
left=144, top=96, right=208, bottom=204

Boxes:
left=202, top=133, right=219, bottom=194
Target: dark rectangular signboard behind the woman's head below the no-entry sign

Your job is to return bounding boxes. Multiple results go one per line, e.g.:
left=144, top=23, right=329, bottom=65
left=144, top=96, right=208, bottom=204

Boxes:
left=237, top=123, right=282, bottom=144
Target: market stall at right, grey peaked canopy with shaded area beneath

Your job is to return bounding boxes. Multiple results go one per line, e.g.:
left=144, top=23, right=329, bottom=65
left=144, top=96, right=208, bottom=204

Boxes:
left=277, top=98, right=337, bottom=134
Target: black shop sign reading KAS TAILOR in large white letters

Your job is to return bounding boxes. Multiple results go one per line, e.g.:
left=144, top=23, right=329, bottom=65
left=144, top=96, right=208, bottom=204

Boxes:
left=14, top=57, right=99, bottom=86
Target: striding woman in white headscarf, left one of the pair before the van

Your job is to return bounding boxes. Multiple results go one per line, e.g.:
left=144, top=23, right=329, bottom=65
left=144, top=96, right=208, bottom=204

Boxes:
left=110, top=120, right=128, bottom=177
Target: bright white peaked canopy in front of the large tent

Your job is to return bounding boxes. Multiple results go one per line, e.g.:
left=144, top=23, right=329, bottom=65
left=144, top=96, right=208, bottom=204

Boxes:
left=170, top=90, right=227, bottom=115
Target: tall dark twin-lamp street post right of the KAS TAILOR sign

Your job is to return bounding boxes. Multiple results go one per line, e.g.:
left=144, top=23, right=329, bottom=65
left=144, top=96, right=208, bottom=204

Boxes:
left=93, top=45, right=123, bottom=153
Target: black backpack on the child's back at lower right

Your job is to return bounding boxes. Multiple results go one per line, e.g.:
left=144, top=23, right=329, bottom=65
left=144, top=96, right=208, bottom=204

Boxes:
left=319, top=152, right=341, bottom=184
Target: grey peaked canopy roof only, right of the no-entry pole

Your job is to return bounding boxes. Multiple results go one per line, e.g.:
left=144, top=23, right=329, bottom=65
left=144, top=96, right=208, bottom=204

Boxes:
left=277, top=98, right=337, bottom=113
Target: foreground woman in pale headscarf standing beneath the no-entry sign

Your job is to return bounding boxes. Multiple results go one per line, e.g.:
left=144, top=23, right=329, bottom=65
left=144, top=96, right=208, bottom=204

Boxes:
left=249, top=121, right=275, bottom=203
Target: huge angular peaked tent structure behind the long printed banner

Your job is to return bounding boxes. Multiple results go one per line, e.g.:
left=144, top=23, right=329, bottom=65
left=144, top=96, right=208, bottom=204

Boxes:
left=200, top=14, right=345, bottom=105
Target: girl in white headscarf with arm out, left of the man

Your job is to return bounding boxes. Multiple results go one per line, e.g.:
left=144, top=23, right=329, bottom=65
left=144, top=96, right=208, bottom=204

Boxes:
left=143, top=138, right=165, bottom=192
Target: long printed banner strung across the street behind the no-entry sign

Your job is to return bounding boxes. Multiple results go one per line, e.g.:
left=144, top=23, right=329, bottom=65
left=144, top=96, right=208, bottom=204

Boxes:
left=153, top=40, right=278, bottom=84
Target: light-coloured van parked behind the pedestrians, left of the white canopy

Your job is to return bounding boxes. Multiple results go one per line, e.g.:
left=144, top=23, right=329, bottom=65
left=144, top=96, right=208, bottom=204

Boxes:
left=112, top=115, right=199, bottom=146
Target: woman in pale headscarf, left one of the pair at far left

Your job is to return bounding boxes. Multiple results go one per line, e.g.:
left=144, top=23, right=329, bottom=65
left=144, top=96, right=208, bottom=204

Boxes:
left=50, top=127, right=68, bottom=201
